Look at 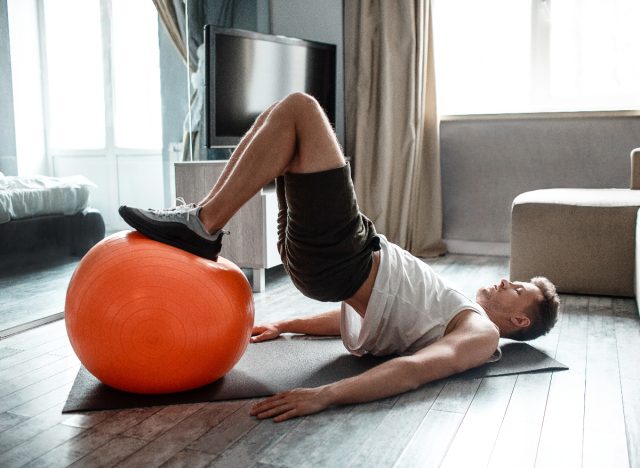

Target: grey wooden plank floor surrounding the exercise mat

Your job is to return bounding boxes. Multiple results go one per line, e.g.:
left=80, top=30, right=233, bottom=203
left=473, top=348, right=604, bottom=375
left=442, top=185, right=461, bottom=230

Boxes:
left=0, top=256, right=640, bottom=468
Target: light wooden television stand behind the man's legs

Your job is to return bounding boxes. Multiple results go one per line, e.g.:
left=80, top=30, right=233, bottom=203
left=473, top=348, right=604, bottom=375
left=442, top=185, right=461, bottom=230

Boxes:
left=175, top=161, right=282, bottom=292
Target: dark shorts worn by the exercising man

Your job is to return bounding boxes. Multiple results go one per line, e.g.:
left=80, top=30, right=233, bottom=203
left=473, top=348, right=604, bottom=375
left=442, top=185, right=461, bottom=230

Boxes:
left=276, top=164, right=380, bottom=302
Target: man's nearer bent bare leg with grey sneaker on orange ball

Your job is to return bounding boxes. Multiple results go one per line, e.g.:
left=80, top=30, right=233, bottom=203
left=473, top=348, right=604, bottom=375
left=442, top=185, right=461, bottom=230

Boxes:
left=120, top=93, right=345, bottom=259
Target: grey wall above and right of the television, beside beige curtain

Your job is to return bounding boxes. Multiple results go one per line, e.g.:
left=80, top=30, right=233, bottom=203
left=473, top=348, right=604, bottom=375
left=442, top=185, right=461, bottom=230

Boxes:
left=271, top=0, right=344, bottom=147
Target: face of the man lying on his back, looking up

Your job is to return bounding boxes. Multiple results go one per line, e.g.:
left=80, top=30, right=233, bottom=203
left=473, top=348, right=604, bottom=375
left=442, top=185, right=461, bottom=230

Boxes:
left=476, top=279, right=544, bottom=315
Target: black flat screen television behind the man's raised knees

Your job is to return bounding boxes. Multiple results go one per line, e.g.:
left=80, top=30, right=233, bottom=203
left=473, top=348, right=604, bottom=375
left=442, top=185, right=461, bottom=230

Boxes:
left=204, top=25, right=336, bottom=148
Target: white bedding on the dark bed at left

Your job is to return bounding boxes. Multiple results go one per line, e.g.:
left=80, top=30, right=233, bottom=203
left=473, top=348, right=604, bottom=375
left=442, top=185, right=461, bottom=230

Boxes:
left=0, top=173, right=95, bottom=224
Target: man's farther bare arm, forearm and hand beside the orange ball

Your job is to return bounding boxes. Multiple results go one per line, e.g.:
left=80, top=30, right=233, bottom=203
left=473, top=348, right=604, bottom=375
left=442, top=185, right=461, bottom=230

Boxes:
left=251, top=309, right=340, bottom=343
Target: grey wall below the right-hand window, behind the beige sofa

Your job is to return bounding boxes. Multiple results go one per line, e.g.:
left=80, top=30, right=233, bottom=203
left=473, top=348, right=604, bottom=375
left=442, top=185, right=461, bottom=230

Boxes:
left=440, top=113, right=640, bottom=254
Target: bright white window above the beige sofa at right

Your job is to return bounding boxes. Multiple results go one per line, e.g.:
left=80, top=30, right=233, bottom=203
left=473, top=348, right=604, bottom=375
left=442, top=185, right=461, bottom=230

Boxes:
left=433, top=0, right=640, bottom=114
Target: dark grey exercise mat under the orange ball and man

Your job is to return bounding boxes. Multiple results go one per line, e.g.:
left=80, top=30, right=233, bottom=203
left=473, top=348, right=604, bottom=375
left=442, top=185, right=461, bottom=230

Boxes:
left=62, top=336, right=568, bottom=413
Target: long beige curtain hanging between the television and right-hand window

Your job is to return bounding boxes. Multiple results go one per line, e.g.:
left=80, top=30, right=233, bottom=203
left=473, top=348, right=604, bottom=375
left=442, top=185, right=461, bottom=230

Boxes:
left=345, top=0, right=446, bottom=257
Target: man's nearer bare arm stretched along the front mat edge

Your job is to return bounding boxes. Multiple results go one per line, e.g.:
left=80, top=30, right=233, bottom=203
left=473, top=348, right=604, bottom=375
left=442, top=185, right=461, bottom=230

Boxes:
left=251, top=312, right=499, bottom=421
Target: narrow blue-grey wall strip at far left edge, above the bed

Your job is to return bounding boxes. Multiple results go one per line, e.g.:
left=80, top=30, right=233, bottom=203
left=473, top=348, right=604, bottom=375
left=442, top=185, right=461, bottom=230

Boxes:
left=0, top=0, right=18, bottom=175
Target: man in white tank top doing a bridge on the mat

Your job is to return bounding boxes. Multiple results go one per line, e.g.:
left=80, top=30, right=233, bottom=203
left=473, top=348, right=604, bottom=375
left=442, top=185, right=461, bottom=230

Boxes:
left=120, top=93, right=558, bottom=421
